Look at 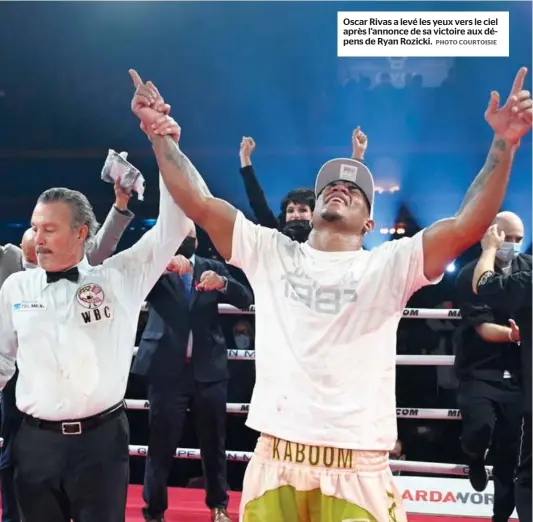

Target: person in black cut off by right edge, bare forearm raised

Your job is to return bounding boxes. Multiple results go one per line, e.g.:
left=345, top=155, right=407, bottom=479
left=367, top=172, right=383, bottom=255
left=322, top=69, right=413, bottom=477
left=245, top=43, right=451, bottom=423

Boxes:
left=472, top=226, right=533, bottom=522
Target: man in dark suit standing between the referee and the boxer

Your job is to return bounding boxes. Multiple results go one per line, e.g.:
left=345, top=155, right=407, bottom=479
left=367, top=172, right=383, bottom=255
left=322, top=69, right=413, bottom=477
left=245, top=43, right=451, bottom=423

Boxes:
left=132, top=229, right=253, bottom=522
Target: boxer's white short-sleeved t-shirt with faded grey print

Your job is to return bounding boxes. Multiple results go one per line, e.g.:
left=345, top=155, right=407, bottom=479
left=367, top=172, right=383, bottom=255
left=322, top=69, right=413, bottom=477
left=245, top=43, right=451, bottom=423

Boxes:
left=229, top=212, right=440, bottom=451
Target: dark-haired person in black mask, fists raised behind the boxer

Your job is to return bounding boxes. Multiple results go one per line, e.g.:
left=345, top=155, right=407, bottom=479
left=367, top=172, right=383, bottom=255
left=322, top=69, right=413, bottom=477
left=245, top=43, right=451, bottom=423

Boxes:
left=235, top=127, right=368, bottom=243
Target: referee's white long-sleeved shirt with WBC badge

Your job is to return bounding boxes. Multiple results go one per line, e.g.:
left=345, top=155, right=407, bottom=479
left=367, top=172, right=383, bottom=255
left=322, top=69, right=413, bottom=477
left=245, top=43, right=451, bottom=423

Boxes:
left=0, top=179, right=192, bottom=421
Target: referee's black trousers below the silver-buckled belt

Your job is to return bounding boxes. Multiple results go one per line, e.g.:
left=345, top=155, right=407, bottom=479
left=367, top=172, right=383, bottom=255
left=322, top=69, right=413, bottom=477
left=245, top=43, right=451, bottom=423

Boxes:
left=14, top=411, right=129, bottom=522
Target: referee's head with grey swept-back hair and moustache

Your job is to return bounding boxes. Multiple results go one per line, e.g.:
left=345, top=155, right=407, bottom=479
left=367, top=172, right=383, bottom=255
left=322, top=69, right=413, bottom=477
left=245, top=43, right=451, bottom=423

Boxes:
left=31, top=188, right=98, bottom=272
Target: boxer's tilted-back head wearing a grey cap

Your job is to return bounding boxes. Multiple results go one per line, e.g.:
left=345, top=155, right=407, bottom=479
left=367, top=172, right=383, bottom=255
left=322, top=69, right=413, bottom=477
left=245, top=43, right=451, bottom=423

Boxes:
left=312, top=158, right=374, bottom=250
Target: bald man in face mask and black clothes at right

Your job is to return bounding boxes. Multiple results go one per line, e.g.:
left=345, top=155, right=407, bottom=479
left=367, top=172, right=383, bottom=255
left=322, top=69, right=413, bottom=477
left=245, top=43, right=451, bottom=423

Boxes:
left=455, top=212, right=531, bottom=522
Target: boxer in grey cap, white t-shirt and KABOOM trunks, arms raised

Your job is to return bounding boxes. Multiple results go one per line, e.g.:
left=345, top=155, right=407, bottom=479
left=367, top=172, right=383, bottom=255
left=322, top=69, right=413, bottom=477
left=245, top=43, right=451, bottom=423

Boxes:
left=138, top=68, right=532, bottom=522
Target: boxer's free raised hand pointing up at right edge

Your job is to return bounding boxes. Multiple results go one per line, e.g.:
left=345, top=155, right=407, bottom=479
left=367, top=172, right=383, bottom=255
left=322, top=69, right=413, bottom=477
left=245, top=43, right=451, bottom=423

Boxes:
left=485, top=67, right=533, bottom=143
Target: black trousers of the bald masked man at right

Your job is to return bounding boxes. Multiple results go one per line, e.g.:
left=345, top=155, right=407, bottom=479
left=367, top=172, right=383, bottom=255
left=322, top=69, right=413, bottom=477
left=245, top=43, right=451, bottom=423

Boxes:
left=457, top=379, right=523, bottom=522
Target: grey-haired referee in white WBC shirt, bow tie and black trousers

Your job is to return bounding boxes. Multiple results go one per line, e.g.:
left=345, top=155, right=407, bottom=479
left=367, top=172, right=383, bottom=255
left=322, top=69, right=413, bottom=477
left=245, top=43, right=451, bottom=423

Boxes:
left=0, top=78, right=192, bottom=522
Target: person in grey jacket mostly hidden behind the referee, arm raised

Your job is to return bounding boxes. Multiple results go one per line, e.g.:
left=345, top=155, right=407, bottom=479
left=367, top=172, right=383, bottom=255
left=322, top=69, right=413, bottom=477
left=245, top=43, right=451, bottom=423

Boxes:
left=0, top=183, right=134, bottom=522
